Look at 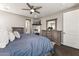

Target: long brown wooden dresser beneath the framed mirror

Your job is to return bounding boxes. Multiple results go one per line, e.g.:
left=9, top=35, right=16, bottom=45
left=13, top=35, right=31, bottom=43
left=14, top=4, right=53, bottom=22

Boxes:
left=42, top=30, right=61, bottom=46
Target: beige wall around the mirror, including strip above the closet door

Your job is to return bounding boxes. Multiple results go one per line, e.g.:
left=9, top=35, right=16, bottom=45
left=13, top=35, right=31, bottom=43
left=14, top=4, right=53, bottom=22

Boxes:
left=41, top=5, right=79, bottom=31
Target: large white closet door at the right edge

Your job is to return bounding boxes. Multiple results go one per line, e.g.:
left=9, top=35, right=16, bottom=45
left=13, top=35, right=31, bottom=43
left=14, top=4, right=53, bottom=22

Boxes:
left=63, top=9, right=79, bottom=49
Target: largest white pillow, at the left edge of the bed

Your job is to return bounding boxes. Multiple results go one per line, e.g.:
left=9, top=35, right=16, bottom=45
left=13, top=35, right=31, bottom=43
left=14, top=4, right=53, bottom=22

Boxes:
left=0, top=30, right=9, bottom=48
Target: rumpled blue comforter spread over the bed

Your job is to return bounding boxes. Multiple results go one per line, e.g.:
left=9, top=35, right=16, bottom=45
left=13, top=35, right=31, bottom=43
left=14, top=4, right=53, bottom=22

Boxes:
left=0, top=34, right=53, bottom=56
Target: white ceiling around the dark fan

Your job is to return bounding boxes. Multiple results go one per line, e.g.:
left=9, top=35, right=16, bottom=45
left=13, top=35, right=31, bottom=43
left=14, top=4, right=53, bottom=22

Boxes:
left=0, top=3, right=76, bottom=18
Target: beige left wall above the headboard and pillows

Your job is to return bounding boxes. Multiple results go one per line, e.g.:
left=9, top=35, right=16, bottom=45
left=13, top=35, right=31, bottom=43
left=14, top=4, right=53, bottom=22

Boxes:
left=0, top=11, right=25, bottom=27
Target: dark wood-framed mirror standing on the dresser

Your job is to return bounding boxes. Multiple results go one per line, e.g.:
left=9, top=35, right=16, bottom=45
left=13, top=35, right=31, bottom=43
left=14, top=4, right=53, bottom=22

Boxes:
left=46, top=18, right=57, bottom=31
